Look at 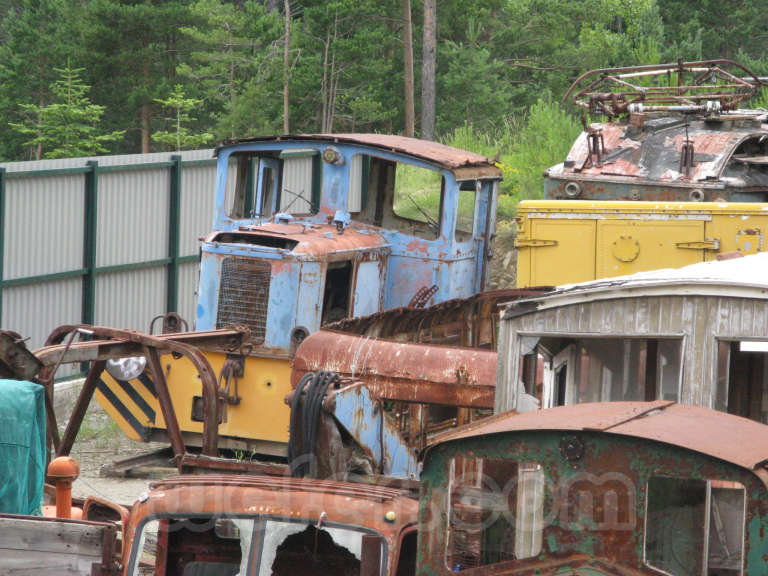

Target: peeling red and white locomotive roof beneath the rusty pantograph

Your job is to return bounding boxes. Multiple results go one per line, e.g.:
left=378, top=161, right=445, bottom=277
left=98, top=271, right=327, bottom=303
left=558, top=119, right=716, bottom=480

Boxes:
left=547, top=113, right=768, bottom=186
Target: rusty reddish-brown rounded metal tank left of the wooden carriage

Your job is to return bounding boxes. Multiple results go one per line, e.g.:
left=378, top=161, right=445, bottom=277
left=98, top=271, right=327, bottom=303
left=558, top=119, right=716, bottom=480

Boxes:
left=291, top=330, right=497, bottom=408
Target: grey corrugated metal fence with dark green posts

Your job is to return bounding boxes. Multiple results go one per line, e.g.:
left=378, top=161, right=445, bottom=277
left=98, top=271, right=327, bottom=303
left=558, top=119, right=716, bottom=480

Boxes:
left=0, top=150, right=216, bottom=366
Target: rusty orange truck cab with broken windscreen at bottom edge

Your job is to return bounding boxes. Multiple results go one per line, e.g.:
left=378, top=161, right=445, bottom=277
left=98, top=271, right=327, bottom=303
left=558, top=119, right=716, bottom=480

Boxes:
left=123, top=476, right=418, bottom=576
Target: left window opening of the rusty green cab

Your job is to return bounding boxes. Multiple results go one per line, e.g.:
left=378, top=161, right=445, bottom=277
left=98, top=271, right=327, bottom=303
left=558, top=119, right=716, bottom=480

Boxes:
left=445, top=457, right=544, bottom=572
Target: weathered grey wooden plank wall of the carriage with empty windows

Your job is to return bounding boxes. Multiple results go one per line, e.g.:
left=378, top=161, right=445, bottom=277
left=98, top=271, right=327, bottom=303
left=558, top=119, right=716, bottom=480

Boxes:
left=495, top=289, right=768, bottom=412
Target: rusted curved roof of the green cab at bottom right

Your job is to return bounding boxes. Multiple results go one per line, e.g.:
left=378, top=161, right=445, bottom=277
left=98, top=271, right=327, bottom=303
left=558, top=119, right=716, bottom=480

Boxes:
left=431, top=401, right=768, bottom=470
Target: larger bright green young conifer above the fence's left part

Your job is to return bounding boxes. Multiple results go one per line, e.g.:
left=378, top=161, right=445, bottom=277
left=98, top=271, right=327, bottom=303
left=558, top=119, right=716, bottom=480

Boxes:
left=10, top=65, right=124, bottom=158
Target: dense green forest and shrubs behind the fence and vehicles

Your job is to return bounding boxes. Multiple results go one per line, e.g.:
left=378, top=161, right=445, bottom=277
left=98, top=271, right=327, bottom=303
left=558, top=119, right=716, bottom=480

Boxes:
left=0, top=0, right=768, bottom=206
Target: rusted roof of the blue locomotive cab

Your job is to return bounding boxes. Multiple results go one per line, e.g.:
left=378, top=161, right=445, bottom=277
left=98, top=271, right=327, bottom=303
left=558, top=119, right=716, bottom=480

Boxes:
left=216, top=134, right=501, bottom=178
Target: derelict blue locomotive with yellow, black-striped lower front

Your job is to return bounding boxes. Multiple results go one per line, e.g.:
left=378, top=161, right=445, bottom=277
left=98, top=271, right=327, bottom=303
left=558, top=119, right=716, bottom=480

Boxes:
left=97, top=134, right=501, bottom=456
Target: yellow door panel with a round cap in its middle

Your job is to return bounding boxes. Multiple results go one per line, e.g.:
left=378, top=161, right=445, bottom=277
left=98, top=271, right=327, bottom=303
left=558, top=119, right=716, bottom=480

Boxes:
left=596, top=219, right=704, bottom=278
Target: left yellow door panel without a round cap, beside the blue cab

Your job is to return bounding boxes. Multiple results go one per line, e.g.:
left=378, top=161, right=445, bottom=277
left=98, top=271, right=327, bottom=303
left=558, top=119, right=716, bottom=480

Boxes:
left=518, top=218, right=595, bottom=287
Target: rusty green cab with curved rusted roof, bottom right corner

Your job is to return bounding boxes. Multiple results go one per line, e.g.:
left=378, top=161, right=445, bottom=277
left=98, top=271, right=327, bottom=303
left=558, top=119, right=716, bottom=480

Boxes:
left=417, top=401, right=768, bottom=576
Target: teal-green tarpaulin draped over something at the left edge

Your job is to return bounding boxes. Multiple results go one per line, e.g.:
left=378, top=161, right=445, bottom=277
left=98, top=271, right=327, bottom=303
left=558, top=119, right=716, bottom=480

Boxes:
left=0, top=380, right=46, bottom=514
